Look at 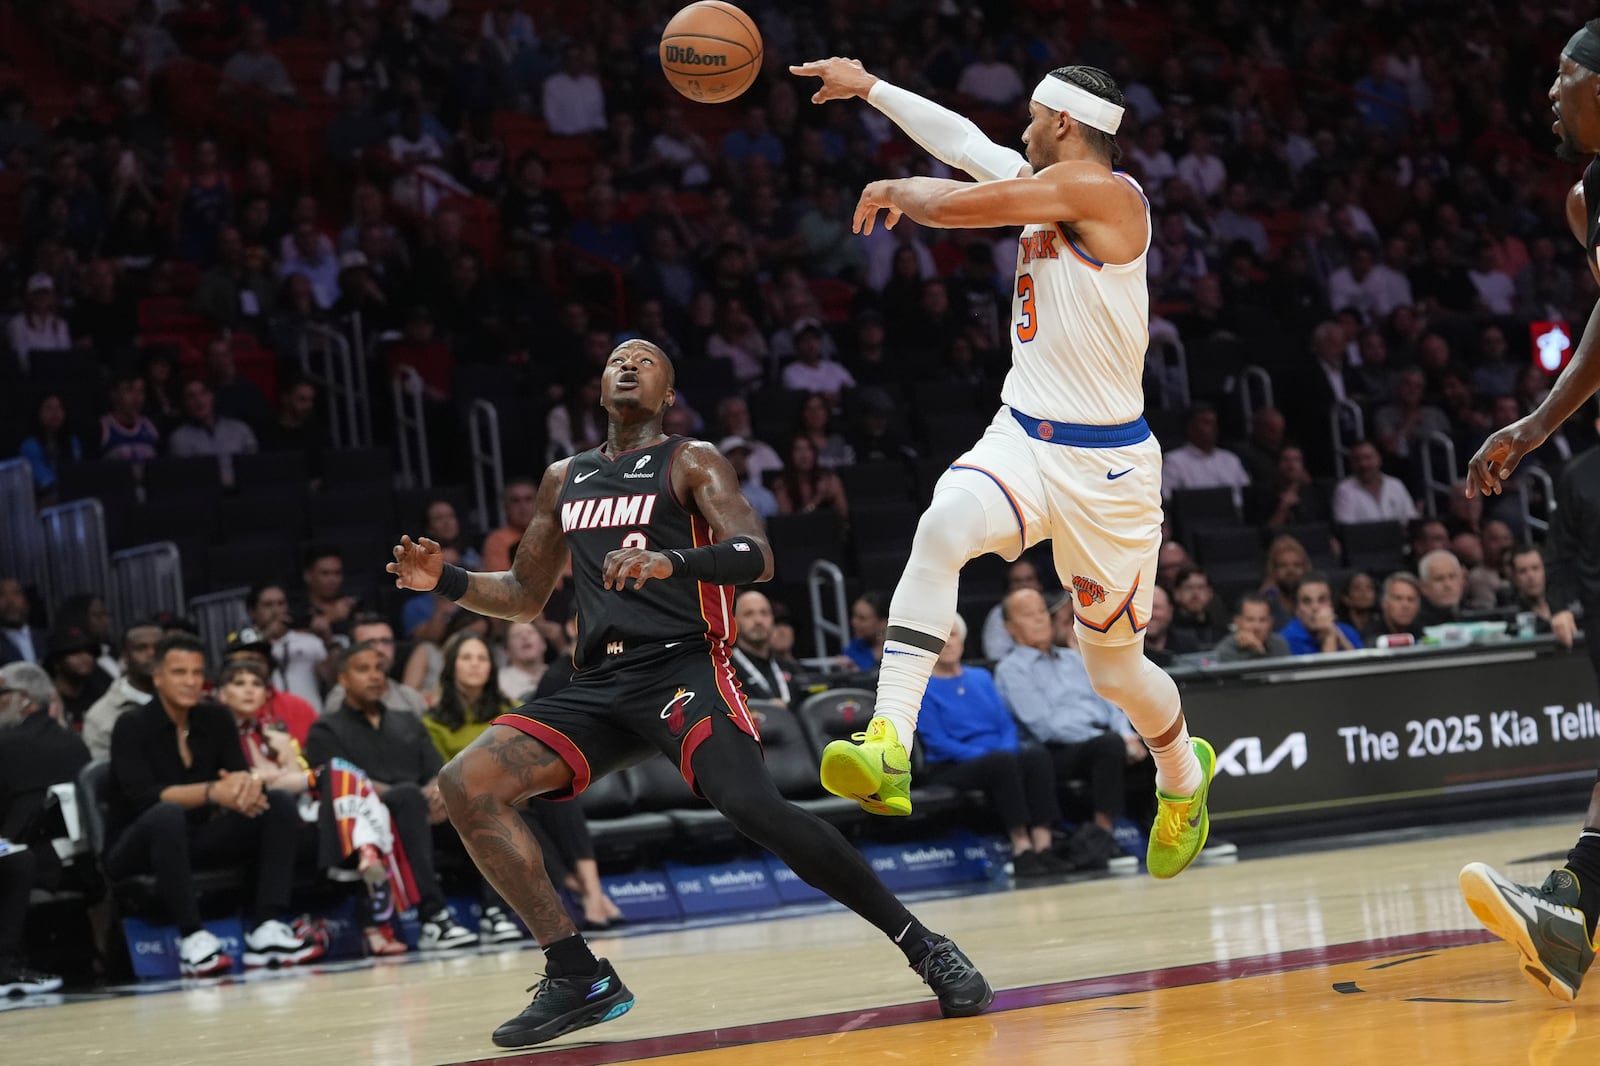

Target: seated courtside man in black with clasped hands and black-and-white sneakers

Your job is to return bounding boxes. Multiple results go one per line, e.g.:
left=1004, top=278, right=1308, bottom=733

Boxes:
left=104, top=634, right=323, bottom=976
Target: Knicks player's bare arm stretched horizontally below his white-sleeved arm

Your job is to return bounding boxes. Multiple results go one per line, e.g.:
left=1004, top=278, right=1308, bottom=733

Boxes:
left=854, top=162, right=1144, bottom=234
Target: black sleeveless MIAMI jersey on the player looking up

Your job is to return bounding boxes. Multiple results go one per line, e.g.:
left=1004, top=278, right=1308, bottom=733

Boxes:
left=558, top=437, right=734, bottom=669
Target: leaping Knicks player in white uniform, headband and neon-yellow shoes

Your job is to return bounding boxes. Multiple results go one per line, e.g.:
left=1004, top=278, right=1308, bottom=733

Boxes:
left=790, top=59, right=1216, bottom=877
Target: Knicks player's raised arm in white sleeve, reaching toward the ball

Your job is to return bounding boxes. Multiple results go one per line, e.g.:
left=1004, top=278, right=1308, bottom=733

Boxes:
left=789, top=56, right=1034, bottom=181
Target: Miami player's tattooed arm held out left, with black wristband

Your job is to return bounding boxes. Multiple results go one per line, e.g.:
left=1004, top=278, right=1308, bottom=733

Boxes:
left=387, top=459, right=568, bottom=621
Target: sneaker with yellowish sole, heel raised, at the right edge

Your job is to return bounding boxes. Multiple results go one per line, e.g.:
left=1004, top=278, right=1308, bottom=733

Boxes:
left=1461, top=863, right=1595, bottom=1004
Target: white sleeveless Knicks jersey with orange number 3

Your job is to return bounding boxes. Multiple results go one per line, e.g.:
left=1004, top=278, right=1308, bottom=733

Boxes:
left=1000, top=171, right=1152, bottom=426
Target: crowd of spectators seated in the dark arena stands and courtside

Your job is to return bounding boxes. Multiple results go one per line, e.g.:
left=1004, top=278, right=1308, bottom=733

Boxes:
left=0, top=0, right=1597, bottom=984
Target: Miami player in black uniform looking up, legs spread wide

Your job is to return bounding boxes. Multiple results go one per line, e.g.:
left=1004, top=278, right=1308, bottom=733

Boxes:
left=389, top=341, right=994, bottom=1047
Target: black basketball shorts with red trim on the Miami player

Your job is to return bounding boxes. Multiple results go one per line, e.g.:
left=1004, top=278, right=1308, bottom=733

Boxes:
left=494, top=639, right=762, bottom=800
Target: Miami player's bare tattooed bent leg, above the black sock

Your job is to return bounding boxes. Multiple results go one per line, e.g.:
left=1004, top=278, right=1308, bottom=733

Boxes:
left=438, top=725, right=578, bottom=944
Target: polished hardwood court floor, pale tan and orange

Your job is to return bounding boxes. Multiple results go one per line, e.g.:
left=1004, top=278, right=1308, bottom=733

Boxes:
left=0, top=820, right=1600, bottom=1066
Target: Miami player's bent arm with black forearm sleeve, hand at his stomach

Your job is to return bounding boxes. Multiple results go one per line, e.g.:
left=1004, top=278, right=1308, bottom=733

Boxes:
left=605, top=440, right=773, bottom=589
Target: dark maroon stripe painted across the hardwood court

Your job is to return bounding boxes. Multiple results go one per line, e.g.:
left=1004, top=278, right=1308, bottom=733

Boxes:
left=448, top=930, right=1494, bottom=1066
